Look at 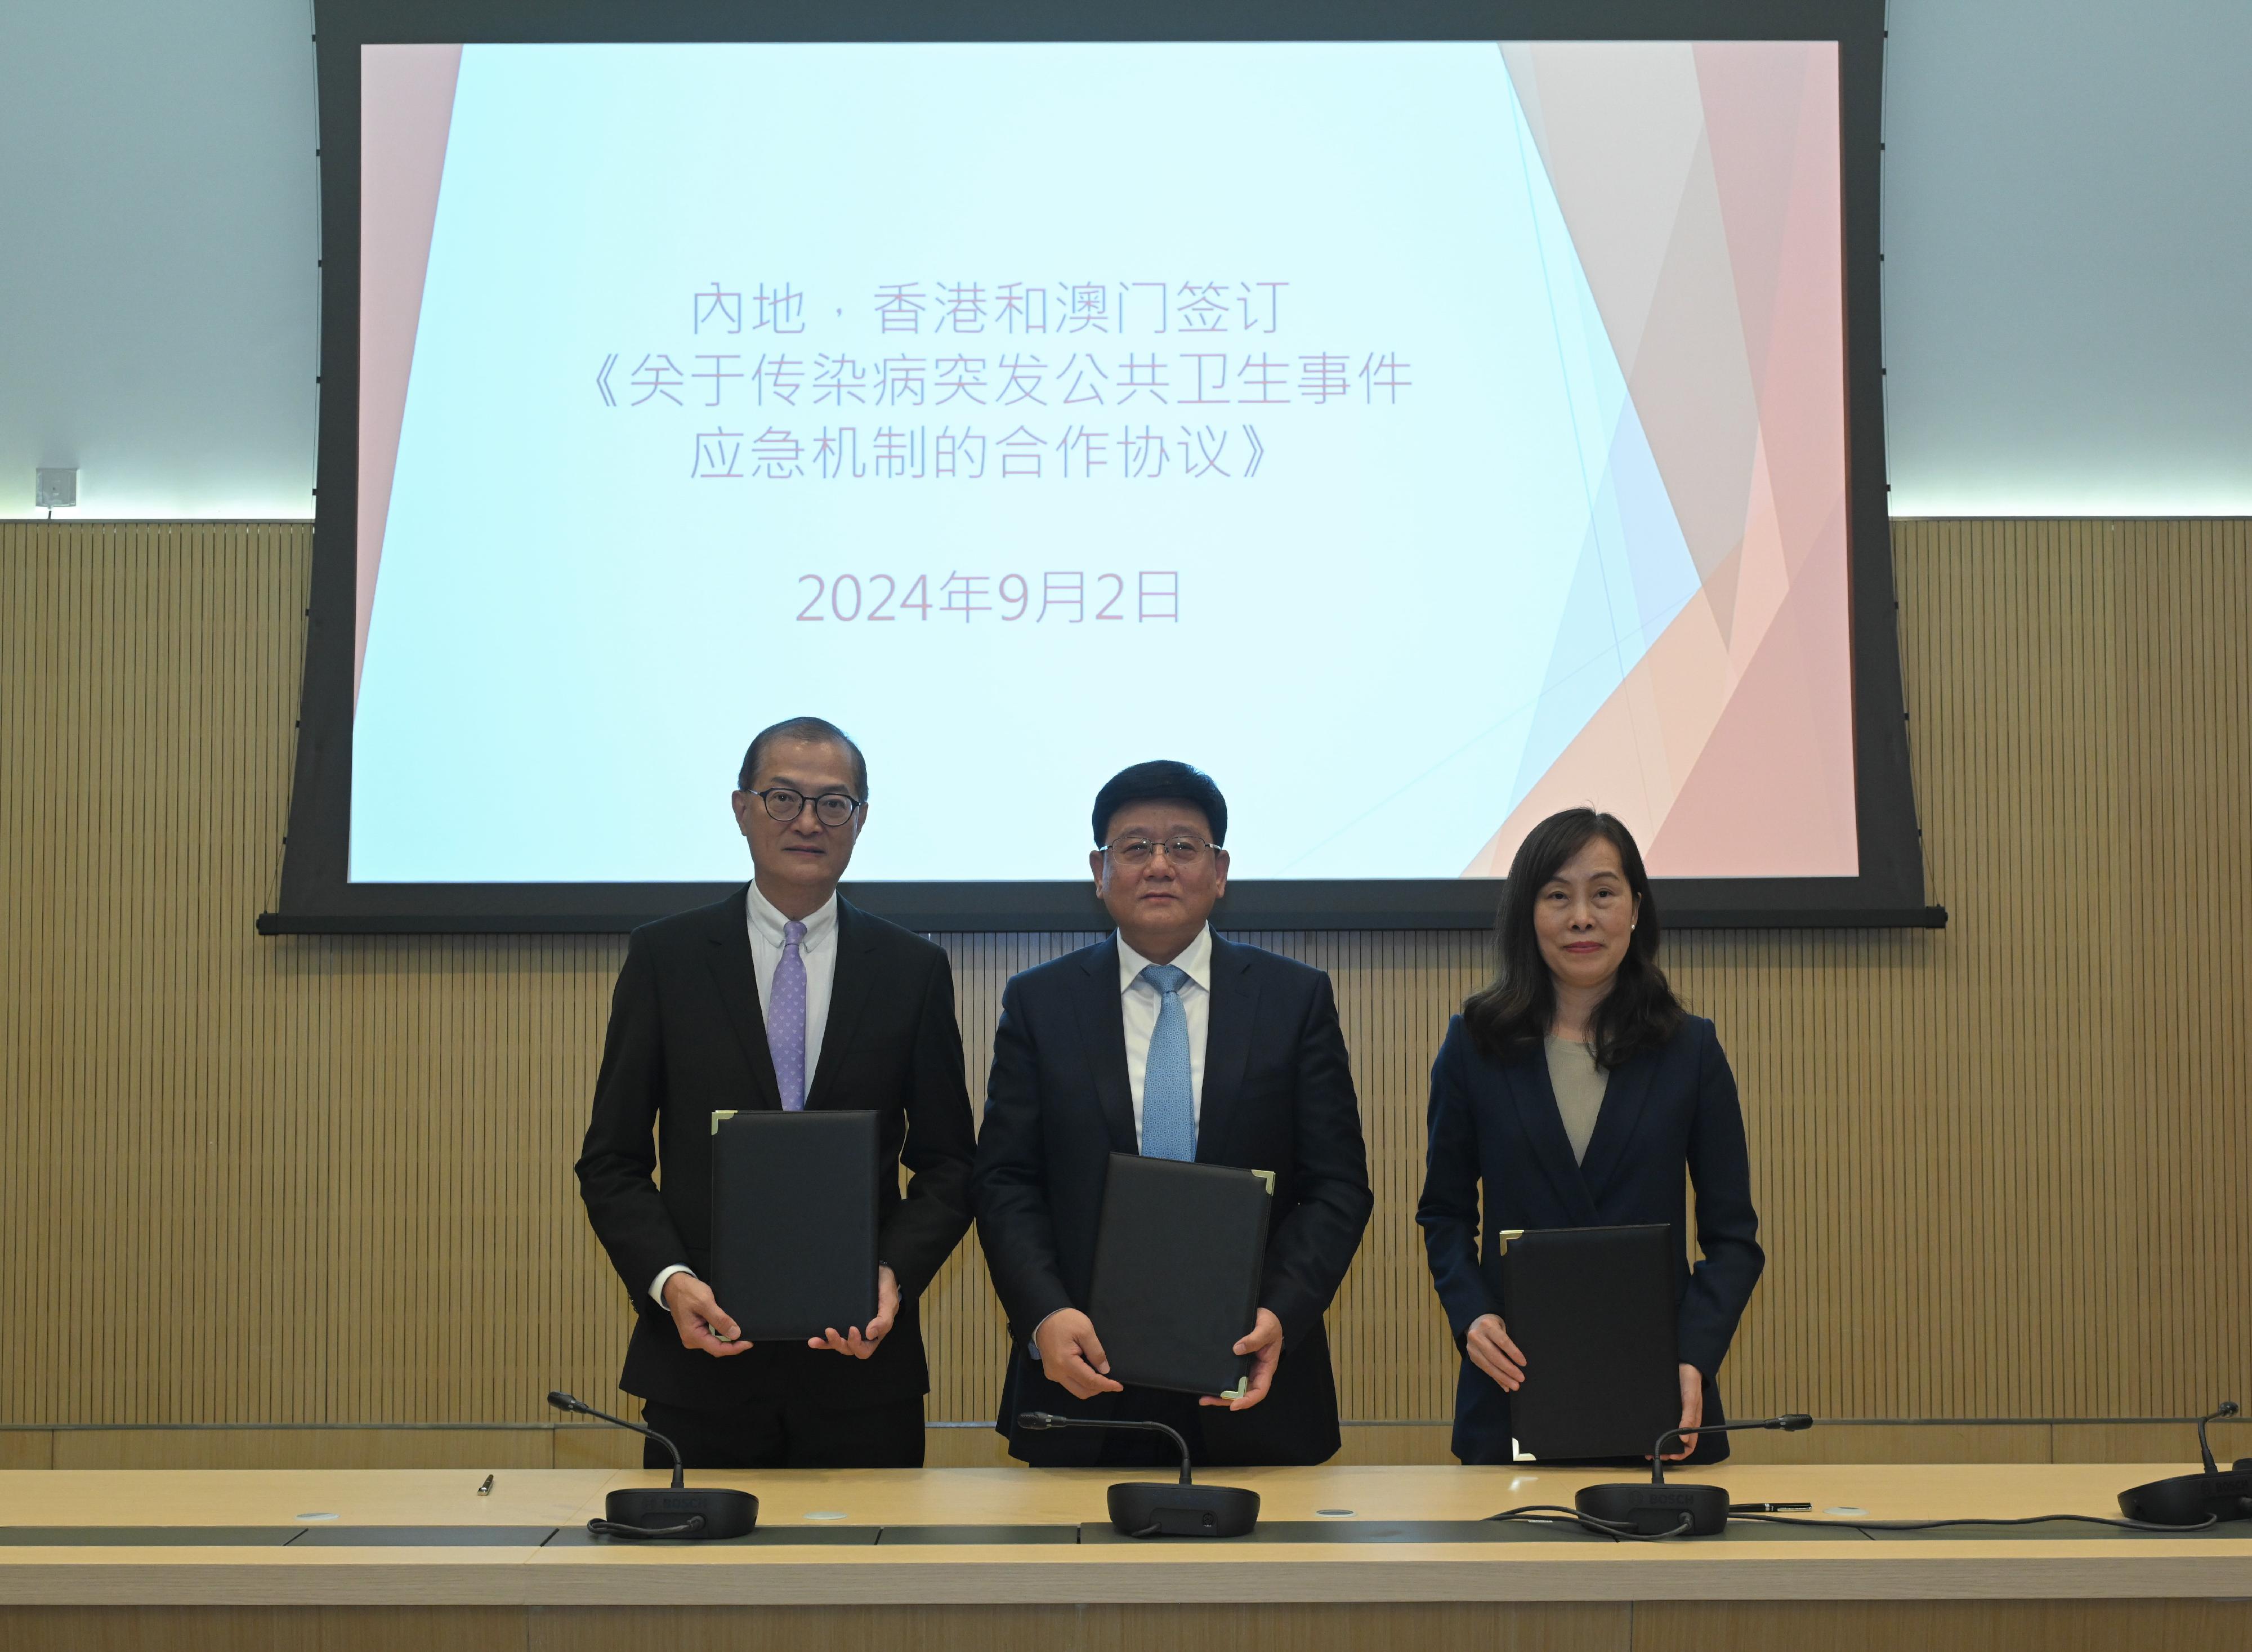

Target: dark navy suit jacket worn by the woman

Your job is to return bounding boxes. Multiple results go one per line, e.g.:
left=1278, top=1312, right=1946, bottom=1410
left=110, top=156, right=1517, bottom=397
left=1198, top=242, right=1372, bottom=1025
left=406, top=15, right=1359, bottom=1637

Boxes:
left=1417, top=1015, right=1766, bottom=1463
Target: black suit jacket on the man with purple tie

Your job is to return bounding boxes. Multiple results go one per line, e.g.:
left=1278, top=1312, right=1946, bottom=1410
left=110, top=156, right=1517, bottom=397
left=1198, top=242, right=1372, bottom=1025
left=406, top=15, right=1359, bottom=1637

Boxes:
left=579, top=891, right=975, bottom=1411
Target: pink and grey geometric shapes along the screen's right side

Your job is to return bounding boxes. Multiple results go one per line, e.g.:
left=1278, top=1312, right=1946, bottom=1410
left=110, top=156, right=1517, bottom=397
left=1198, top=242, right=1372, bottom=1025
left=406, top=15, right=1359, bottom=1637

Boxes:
left=1464, top=43, right=1860, bottom=878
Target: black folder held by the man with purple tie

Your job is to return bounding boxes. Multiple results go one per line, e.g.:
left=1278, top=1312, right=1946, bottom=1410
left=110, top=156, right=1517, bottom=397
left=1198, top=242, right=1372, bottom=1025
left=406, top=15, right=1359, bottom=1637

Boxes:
left=712, top=1110, right=878, bottom=1341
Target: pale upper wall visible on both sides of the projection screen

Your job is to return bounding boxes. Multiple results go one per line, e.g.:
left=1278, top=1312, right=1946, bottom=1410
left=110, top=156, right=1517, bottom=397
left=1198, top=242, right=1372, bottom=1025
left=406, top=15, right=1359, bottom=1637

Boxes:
left=0, top=0, right=2252, bottom=517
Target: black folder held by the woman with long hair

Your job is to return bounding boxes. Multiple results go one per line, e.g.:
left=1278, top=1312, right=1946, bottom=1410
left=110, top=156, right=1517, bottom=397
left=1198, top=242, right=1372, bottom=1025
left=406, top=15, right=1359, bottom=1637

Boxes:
left=1486, top=1222, right=1682, bottom=1458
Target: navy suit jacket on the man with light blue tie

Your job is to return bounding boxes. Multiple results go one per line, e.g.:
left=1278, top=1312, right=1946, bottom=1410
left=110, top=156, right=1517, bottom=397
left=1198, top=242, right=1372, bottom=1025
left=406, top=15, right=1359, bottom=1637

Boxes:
left=977, top=936, right=1374, bottom=1465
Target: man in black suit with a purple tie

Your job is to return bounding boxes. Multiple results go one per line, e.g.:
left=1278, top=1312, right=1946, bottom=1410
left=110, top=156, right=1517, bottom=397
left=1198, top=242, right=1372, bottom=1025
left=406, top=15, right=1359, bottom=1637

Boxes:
left=579, top=718, right=975, bottom=1467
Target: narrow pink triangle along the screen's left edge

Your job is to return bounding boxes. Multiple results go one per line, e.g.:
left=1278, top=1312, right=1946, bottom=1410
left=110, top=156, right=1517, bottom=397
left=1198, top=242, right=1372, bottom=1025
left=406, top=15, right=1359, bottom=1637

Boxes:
left=351, top=45, right=462, bottom=704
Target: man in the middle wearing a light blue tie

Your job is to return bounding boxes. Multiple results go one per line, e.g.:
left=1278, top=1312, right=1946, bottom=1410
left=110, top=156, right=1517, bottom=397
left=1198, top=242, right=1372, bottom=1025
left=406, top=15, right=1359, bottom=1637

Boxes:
left=977, top=763, right=1374, bottom=1465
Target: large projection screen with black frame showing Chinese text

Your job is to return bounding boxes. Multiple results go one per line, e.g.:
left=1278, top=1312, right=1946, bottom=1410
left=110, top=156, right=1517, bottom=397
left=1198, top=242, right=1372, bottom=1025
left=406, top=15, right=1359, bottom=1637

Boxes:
left=261, top=2, right=1934, bottom=930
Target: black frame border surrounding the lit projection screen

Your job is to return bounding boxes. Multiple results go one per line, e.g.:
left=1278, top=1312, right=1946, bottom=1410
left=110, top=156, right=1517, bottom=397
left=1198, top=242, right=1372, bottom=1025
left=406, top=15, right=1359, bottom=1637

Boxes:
left=277, top=0, right=1946, bottom=934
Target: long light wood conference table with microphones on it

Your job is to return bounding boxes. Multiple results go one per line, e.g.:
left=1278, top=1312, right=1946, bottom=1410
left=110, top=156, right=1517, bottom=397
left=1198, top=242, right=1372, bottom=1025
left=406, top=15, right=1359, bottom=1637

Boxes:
left=0, top=1463, right=2252, bottom=1652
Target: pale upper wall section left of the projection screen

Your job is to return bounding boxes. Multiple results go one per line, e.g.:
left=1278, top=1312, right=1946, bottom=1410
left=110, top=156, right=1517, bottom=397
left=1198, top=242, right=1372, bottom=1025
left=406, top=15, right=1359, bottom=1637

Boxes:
left=0, top=0, right=320, bottom=517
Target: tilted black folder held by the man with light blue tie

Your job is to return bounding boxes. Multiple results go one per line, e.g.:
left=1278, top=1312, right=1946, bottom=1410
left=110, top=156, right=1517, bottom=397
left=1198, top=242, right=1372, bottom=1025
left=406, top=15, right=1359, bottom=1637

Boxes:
left=1088, top=1153, right=1275, bottom=1393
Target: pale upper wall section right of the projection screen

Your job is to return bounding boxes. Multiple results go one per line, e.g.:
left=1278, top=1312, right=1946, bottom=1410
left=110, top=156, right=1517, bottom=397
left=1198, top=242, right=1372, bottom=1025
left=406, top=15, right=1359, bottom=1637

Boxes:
left=1885, top=0, right=2252, bottom=515
